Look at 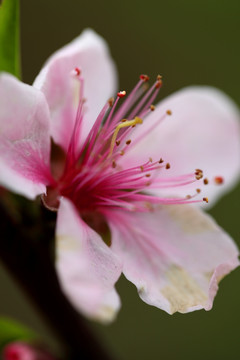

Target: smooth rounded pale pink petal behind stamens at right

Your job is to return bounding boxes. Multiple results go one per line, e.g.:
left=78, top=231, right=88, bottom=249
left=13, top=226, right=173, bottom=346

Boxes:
left=122, top=87, right=240, bottom=204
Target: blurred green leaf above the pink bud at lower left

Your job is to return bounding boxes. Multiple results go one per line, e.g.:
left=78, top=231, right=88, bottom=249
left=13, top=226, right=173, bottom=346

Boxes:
left=0, top=317, right=38, bottom=348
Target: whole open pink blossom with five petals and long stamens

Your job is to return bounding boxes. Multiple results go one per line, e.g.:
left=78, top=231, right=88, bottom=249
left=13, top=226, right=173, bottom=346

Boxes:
left=0, top=30, right=240, bottom=322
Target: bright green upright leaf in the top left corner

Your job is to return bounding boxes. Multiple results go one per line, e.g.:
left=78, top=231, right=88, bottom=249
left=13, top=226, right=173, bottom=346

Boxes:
left=0, top=0, right=20, bottom=78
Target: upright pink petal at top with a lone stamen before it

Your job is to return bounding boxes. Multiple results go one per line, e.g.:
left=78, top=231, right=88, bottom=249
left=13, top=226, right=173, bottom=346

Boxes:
left=34, top=30, right=116, bottom=150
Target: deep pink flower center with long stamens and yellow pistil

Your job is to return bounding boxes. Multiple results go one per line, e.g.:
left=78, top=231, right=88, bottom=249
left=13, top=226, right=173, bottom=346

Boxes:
left=43, top=68, right=221, bottom=217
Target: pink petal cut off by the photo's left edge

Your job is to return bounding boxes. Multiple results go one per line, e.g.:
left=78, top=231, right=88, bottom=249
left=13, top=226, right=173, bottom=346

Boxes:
left=0, top=73, right=50, bottom=198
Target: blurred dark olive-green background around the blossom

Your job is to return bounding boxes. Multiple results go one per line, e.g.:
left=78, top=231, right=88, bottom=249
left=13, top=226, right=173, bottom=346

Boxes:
left=0, top=0, right=240, bottom=360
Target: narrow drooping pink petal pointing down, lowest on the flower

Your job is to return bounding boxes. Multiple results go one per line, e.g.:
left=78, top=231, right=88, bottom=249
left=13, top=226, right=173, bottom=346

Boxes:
left=56, top=199, right=122, bottom=322
